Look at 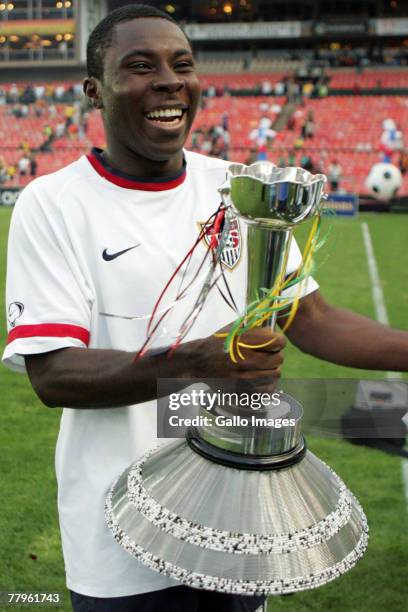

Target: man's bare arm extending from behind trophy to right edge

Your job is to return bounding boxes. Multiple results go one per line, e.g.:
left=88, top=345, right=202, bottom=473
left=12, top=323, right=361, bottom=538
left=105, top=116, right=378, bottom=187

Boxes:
left=279, top=291, right=408, bottom=372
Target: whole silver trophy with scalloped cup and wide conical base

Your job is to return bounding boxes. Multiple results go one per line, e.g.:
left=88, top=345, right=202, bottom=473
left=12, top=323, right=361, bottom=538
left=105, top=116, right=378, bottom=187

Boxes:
left=106, top=162, right=368, bottom=595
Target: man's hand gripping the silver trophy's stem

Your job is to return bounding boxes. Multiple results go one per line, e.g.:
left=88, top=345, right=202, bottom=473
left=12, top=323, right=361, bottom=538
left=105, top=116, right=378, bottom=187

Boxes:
left=178, top=327, right=286, bottom=379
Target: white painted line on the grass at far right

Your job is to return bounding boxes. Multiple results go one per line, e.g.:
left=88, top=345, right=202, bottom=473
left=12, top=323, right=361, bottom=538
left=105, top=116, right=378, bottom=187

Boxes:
left=361, top=221, right=408, bottom=509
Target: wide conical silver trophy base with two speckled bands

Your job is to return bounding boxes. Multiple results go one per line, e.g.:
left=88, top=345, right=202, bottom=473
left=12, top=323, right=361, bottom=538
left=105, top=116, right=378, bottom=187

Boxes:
left=106, top=440, right=368, bottom=595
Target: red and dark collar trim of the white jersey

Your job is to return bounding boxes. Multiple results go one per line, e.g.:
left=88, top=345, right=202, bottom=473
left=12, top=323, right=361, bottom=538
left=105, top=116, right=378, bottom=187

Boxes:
left=86, top=148, right=187, bottom=191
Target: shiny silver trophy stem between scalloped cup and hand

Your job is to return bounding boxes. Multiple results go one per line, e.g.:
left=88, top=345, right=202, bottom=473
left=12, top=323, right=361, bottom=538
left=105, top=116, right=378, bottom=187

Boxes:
left=246, top=223, right=293, bottom=328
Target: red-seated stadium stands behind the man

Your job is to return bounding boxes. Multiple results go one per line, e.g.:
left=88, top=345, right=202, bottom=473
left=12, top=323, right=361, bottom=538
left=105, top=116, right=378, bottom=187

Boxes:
left=0, top=71, right=408, bottom=195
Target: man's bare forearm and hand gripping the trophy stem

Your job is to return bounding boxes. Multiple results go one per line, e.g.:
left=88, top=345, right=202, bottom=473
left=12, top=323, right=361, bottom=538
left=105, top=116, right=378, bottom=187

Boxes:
left=25, top=329, right=286, bottom=408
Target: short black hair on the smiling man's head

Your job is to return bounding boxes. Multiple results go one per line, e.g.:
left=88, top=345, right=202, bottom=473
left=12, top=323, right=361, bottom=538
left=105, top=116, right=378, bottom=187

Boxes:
left=86, top=4, right=184, bottom=79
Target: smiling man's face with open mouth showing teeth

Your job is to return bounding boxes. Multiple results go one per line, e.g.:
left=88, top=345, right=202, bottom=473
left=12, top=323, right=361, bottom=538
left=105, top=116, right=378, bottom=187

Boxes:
left=95, top=18, right=200, bottom=161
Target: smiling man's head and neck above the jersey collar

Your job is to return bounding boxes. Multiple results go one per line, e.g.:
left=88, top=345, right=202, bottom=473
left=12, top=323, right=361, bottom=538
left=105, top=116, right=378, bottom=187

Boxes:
left=84, top=7, right=200, bottom=178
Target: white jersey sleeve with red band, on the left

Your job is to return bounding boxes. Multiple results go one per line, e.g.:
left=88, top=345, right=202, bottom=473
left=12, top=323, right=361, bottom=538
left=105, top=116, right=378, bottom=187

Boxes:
left=3, top=185, right=92, bottom=371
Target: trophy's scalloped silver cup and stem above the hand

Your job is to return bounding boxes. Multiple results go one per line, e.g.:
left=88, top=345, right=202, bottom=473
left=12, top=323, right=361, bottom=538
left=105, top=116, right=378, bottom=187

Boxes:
left=220, top=162, right=326, bottom=327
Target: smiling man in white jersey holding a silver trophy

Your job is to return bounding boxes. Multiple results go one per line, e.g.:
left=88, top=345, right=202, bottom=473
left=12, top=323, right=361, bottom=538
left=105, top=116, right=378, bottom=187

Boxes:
left=4, top=5, right=408, bottom=612
